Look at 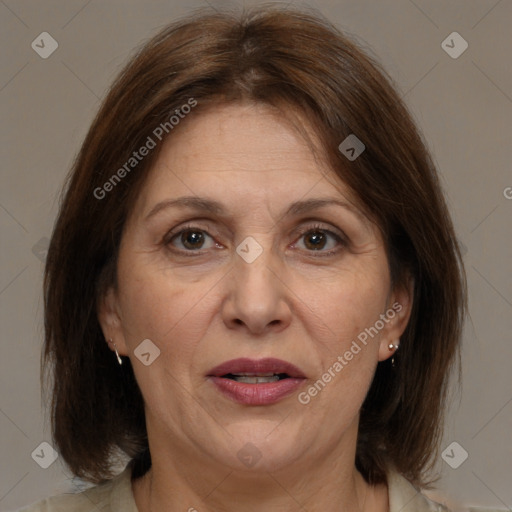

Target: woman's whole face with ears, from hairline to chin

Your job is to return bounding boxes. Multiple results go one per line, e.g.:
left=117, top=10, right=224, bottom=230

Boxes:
left=100, top=104, right=409, bottom=471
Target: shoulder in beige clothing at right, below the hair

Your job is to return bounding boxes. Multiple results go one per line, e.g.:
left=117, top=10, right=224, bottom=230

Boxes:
left=388, top=471, right=450, bottom=512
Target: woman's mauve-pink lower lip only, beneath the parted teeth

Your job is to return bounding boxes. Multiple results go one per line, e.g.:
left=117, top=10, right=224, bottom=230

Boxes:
left=210, top=377, right=305, bottom=405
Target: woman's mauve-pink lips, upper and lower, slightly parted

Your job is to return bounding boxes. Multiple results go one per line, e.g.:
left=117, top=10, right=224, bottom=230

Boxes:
left=208, top=358, right=306, bottom=405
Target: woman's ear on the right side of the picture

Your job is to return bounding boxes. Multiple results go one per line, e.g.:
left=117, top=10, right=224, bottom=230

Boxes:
left=379, top=277, right=414, bottom=361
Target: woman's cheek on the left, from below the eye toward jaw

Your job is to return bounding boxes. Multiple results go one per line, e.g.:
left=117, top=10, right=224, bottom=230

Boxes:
left=116, top=265, right=208, bottom=416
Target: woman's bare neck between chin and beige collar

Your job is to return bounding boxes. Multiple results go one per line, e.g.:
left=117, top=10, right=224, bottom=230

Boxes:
left=133, top=414, right=388, bottom=512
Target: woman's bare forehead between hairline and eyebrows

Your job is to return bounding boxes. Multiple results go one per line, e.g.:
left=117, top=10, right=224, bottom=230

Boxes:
left=132, top=104, right=362, bottom=222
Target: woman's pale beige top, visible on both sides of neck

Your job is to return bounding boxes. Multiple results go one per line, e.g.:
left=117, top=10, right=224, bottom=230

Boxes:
left=18, top=466, right=449, bottom=512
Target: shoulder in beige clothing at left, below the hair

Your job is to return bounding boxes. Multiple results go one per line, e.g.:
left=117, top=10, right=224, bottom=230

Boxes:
left=17, top=467, right=137, bottom=512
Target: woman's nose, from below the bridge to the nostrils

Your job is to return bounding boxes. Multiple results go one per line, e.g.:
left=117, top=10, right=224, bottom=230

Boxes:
left=222, top=245, right=292, bottom=335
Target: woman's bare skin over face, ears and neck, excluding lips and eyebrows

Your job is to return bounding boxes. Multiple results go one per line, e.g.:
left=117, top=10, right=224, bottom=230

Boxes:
left=99, top=103, right=411, bottom=512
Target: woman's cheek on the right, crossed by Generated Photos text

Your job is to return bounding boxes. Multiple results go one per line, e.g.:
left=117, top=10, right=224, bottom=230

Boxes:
left=306, top=264, right=388, bottom=408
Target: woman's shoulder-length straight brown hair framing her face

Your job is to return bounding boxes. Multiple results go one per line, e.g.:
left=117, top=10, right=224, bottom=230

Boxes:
left=43, top=7, right=466, bottom=485
